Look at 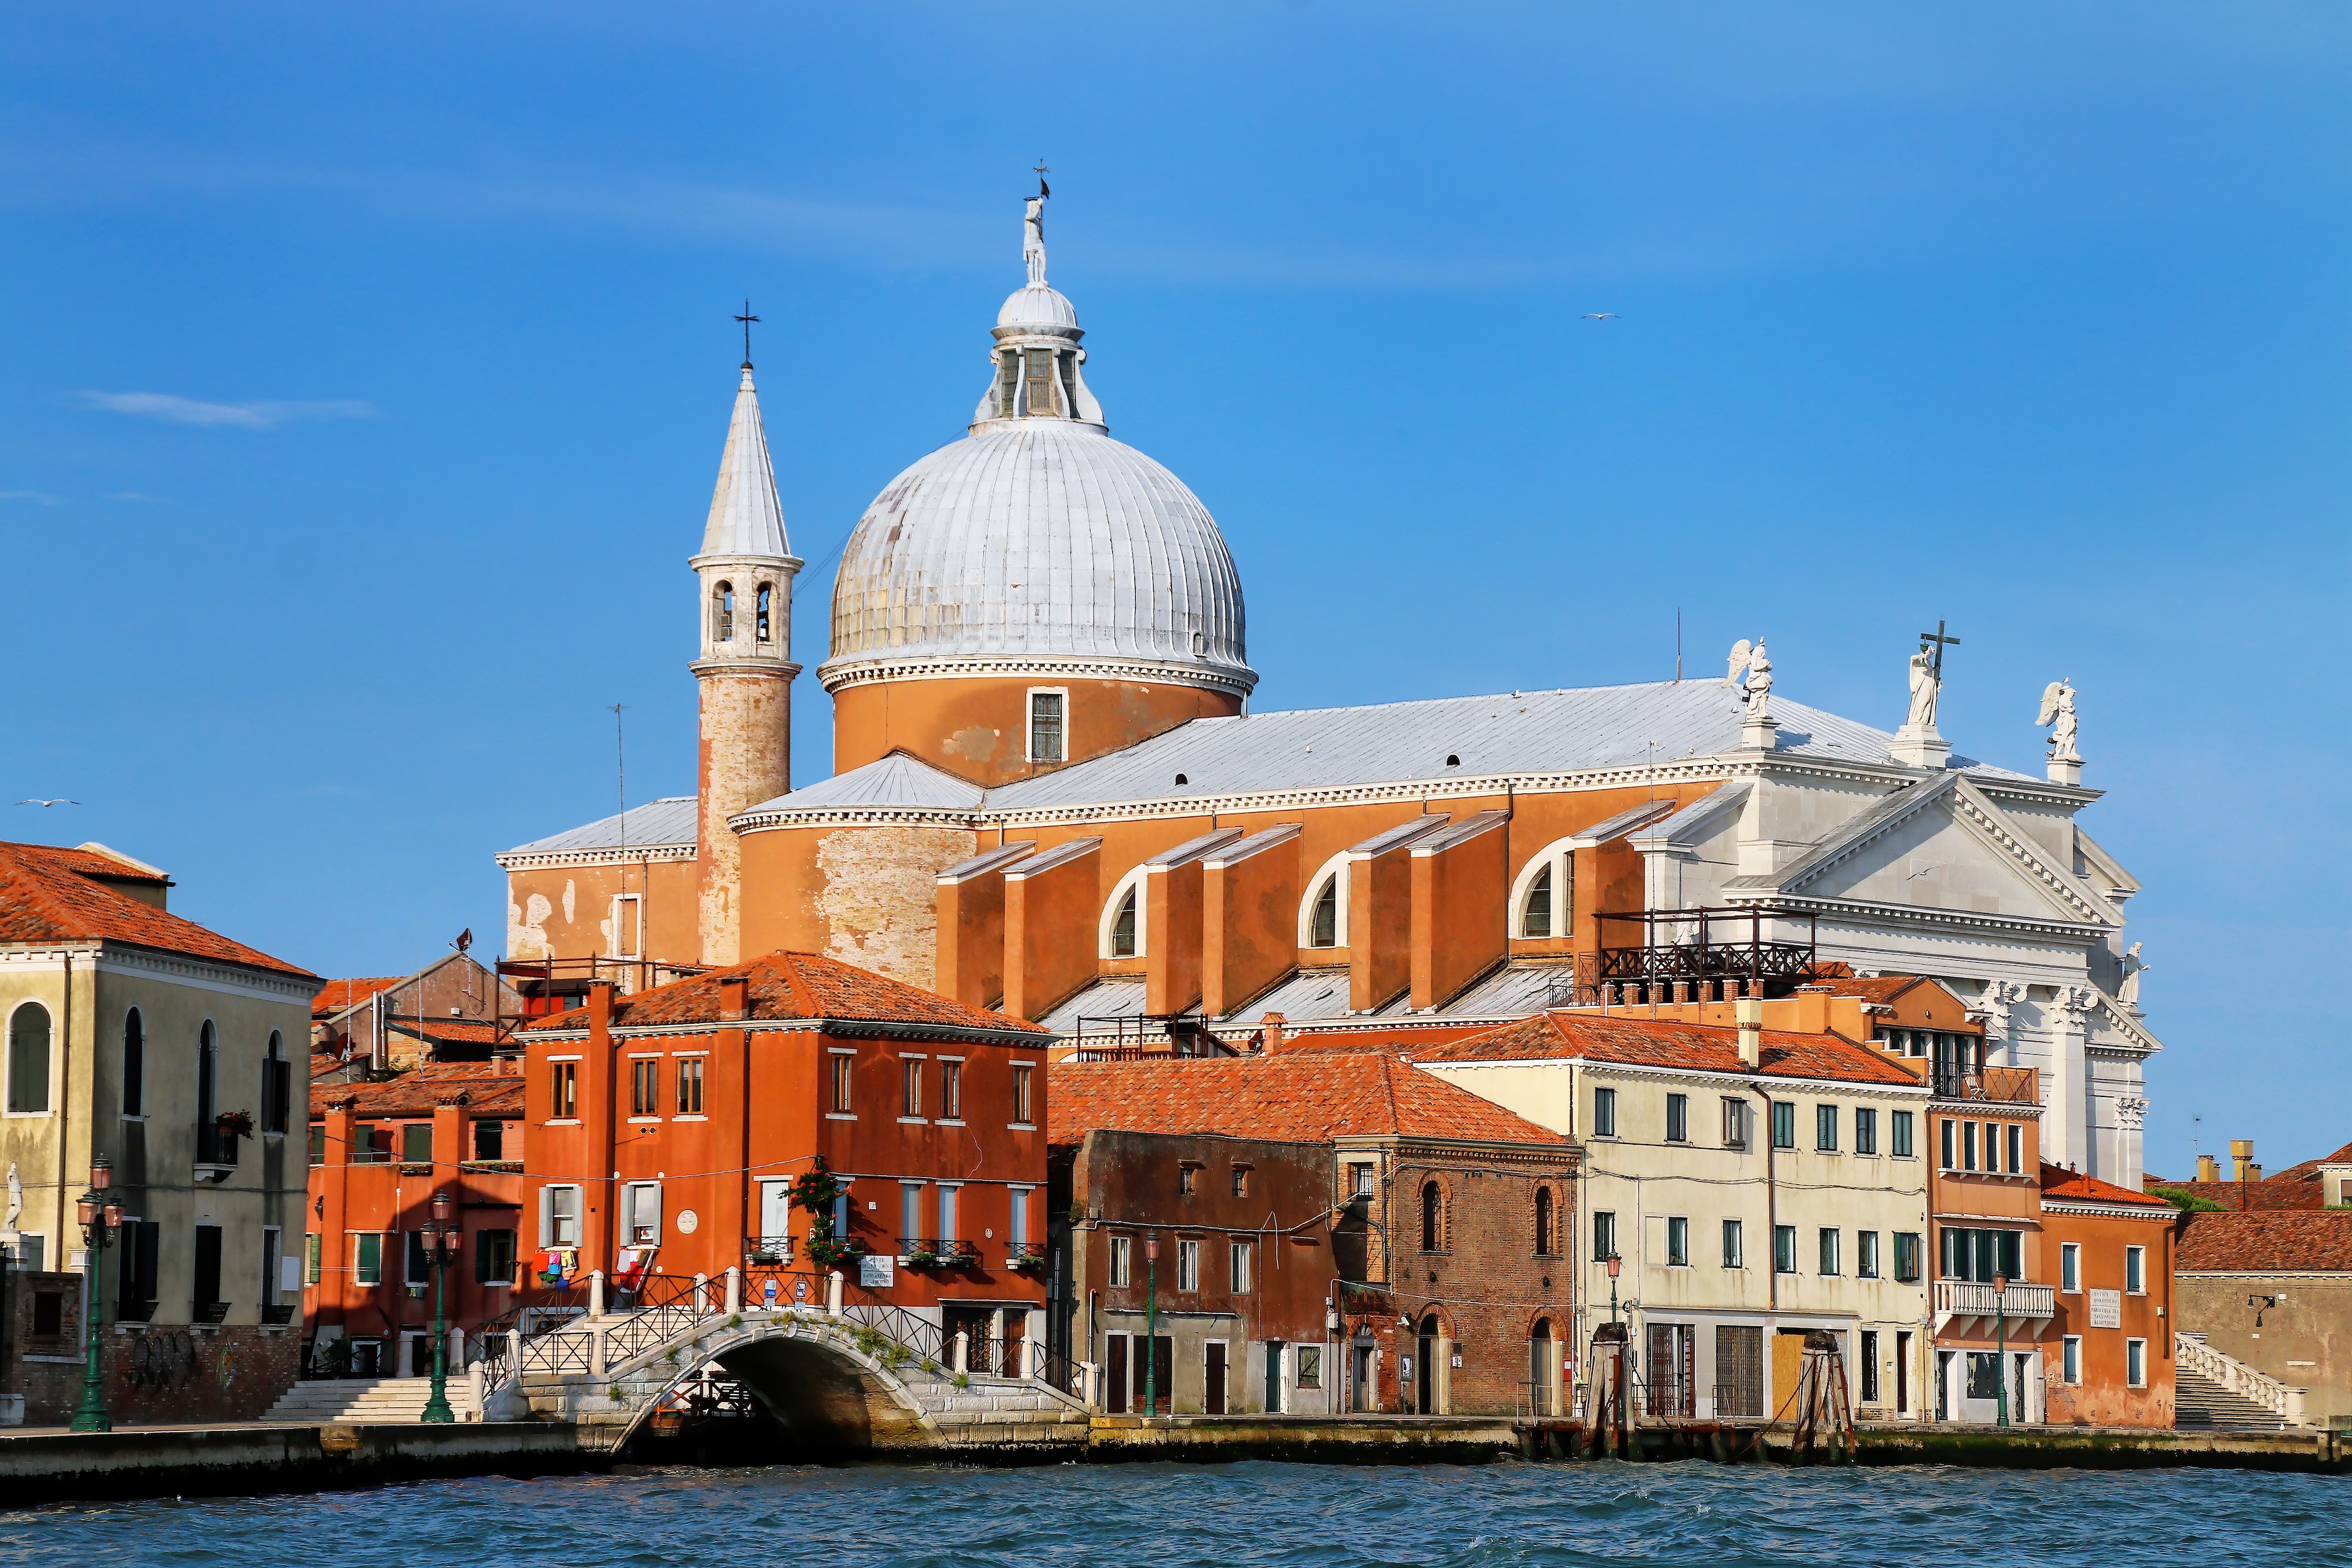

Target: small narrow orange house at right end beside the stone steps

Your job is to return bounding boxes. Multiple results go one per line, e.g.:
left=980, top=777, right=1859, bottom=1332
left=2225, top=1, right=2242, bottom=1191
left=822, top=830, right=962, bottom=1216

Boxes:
left=2042, top=1164, right=2178, bottom=1427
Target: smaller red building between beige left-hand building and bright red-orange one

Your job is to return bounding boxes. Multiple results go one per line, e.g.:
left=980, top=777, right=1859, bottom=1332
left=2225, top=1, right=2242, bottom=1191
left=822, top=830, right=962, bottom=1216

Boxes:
left=304, top=1063, right=527, bottom=1378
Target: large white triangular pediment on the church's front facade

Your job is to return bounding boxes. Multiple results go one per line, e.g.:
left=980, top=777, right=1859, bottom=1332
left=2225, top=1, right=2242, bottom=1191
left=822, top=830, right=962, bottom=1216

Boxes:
left=1729, top=773, right=2124, bottom=926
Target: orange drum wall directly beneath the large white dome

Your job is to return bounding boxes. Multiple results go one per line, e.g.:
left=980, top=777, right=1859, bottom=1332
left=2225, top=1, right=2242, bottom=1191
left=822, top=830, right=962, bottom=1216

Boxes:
left=833, top=674, right=1242, bottom=785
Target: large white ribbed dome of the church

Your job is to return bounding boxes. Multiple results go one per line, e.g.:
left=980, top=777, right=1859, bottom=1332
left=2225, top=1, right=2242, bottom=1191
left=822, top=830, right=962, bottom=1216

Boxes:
left=818, top=421, right=1259, bottom=693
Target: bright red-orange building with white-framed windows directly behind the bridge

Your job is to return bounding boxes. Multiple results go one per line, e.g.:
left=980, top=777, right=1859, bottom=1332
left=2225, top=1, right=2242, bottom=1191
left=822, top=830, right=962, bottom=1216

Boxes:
left=515, top=952, right=1049, bottom=1364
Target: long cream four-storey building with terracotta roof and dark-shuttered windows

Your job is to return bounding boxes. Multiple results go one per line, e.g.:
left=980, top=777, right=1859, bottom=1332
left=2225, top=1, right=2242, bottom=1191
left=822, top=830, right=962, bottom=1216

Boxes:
left=1411, top=992, right=1929, bottom=1420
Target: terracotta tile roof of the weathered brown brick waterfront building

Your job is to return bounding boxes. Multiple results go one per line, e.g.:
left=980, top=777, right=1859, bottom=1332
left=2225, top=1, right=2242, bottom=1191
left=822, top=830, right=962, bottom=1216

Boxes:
left=1047, top=1051, right=1569, bottom=1145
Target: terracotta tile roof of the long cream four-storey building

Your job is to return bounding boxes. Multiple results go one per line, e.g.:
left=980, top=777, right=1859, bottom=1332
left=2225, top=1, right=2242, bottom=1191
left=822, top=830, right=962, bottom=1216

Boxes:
left=1406, top=1011, right=1922, bottom=1088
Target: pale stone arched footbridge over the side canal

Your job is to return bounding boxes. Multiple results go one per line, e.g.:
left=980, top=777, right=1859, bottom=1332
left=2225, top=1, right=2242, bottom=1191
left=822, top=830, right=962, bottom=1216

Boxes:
left=501, top=1272, right=1089, bottom=1458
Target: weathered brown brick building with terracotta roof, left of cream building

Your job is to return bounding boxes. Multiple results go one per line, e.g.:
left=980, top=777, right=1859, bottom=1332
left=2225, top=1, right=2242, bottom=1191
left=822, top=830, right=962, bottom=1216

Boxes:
left=1054, top=1051, right=1579, bottom=1413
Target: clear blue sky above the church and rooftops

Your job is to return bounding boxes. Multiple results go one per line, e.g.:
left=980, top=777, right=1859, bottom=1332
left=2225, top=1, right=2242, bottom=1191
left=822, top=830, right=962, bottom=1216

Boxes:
left=0, top=0, right=2352, bottom=1171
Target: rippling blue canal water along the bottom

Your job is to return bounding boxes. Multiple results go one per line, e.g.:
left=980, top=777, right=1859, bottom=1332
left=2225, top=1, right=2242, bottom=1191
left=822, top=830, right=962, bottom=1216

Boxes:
left=0, top=1463, right=2352, bottom=1568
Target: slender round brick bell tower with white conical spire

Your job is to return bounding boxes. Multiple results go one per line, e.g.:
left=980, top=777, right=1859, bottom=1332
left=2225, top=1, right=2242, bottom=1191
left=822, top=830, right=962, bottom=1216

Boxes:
left=687, top=341, right=802, bottom=964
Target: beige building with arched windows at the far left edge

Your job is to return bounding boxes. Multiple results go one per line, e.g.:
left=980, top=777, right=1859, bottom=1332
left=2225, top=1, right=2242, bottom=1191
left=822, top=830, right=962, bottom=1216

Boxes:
left=0, top=844, right=318, bottom=1422
